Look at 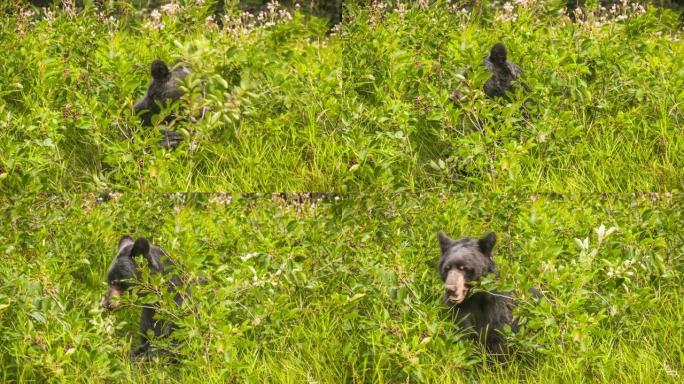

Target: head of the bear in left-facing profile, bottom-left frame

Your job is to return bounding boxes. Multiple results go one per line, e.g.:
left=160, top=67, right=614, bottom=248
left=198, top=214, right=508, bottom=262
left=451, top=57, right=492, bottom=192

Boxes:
left=102, top=236, right=159, bottom=309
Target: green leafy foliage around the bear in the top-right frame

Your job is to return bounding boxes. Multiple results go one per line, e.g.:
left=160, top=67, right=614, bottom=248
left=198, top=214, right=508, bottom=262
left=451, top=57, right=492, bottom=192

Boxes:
left=342, top=1, right=684, bottom=192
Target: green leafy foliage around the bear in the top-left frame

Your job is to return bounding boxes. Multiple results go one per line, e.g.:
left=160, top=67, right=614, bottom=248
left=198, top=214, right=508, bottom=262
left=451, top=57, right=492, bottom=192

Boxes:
left=0, top=2, right=343, bottom=192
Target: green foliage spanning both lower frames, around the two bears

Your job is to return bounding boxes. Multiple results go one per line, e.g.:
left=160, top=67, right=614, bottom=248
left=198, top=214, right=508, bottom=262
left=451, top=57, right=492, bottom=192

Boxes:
left=0, top=194, right=684, bottom=383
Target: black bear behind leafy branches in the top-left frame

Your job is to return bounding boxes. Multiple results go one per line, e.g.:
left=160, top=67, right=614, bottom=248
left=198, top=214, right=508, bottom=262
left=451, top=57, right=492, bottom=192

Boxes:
left=133, top=60, right=190, bottom=148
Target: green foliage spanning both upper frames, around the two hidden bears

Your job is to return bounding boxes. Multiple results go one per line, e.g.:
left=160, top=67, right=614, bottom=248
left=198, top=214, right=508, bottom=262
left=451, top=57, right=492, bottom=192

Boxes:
left=0, top=0, right=684, bottom=192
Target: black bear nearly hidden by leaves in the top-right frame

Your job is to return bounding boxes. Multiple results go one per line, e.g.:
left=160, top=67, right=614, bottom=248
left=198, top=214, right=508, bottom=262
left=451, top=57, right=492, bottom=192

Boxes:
left=484, top=43, right=527, bottom=101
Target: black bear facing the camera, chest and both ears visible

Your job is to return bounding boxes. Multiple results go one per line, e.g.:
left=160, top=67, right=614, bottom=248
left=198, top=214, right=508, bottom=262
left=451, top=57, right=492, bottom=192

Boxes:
left=438, top=231, right=517, bottom=359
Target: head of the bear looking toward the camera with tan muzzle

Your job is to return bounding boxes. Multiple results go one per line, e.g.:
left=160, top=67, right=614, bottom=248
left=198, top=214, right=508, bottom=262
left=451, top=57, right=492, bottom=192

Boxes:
left=438, top=231, right=496, bottom=304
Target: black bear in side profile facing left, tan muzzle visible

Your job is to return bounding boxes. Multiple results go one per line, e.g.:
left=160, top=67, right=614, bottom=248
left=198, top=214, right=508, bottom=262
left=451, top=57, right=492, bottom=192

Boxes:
left=102, top=236, right=183, bottom=358
